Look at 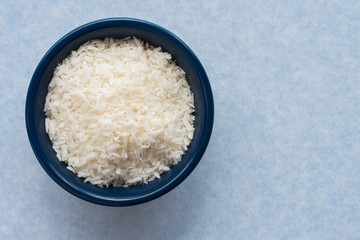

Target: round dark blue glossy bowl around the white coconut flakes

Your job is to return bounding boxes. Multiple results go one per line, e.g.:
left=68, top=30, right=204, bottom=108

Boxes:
left=25, top=18, right=214, bottom=206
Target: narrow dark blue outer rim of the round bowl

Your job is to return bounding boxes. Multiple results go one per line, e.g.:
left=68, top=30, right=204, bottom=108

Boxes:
left=25, top=17, right=214, bottom=206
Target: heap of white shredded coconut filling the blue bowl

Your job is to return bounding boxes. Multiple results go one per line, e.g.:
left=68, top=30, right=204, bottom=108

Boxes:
left=44, top=38, right=194, bottom=187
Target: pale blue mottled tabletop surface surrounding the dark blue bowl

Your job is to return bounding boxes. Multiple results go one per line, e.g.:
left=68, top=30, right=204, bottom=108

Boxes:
left=0, top=0, right=360, bottom=239
